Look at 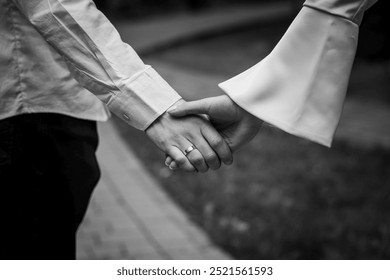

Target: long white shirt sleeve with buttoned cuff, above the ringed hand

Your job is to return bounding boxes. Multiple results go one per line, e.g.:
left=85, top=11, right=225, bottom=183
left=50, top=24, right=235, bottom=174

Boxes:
left=12, top=0, right=181, bottom=130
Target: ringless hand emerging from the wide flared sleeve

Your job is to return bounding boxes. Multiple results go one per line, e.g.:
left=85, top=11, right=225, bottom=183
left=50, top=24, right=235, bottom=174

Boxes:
left=166, top=95, right=263, bottom=168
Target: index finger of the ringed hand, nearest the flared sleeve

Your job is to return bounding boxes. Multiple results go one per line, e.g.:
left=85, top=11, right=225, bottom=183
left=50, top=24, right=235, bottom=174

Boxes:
left=202, top=126, right=233, bottom=165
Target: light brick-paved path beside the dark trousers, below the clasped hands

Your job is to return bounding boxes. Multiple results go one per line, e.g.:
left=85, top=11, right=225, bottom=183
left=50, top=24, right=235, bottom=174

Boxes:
left=77, top=122, right=230, bottom=260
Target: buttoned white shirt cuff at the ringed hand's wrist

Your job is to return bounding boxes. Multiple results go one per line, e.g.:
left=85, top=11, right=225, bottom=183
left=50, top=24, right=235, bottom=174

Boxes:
left=107, top=66, right=181, bottom=130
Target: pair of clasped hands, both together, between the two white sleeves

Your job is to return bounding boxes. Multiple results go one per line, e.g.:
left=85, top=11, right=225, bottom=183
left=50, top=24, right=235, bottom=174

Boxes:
left=146, top=95, right=262, bottom=173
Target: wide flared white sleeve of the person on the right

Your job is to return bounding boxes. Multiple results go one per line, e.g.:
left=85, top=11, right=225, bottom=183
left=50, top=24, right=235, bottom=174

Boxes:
left=219, top=0, right=376, bottom=147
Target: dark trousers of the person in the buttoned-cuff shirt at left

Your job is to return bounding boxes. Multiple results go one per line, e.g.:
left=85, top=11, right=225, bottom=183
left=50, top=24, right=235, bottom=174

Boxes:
left=0, top=113, right=100, bottom=259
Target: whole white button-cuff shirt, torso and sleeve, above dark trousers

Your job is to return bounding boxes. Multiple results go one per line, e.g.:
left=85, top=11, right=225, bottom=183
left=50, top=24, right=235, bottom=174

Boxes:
left=0, top=0, right=181, bottom=130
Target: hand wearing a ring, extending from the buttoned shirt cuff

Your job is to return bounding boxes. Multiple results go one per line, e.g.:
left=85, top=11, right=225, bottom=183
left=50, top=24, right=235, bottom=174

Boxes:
left=146, top=101, right=233, bottom=172
